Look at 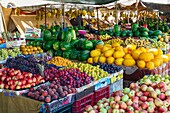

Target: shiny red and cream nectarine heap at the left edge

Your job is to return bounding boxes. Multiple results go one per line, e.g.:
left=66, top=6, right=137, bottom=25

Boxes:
left=0, top=68, right=45, bottom=90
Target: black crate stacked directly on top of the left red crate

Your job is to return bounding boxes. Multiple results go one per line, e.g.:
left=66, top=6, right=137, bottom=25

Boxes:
left=75, top=86, right=95, bottom=100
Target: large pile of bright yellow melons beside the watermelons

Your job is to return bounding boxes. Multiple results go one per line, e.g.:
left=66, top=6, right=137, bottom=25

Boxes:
left=87, top=43, right=170, bottom=70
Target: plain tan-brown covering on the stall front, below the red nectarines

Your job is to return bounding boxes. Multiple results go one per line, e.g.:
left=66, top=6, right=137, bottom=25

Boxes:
left=0, top=92, right=42, bottom=113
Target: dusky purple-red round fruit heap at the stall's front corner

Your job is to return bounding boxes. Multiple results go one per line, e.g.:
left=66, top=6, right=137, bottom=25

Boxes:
left=27, top=81, right=76, bottom=103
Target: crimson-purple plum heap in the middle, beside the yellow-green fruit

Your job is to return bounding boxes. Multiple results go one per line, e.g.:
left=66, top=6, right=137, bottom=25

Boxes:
left=44, top=67, right=93, bottom=88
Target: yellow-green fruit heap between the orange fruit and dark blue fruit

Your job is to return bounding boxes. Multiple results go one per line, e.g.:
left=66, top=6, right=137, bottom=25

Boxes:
left=67, top=63, right=109, bottom=80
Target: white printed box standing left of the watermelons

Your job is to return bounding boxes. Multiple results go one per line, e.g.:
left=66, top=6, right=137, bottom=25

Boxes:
left=25, top=28, right=41, bottom=38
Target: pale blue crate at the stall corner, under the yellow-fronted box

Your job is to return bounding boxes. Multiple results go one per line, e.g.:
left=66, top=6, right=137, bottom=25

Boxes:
left=110, top=79, right=123, bottom=94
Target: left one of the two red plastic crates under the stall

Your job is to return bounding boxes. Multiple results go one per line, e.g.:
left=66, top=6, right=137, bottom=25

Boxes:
left=72, top=93, right=94, bottom=113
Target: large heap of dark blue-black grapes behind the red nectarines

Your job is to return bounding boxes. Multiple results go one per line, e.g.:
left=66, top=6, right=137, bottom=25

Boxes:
left=5, top=55, right=45, bottom=74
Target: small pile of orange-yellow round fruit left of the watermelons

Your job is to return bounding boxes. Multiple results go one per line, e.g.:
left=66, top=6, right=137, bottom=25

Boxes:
left=20, top=45, right=43, bottom=55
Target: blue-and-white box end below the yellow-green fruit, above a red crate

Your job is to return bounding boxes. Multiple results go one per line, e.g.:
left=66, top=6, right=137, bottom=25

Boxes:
left=94, top=78, right=110, bottom=91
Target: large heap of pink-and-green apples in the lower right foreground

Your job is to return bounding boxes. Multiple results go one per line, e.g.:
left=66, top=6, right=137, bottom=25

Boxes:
left=84, top=82, right=170, bottom=113
